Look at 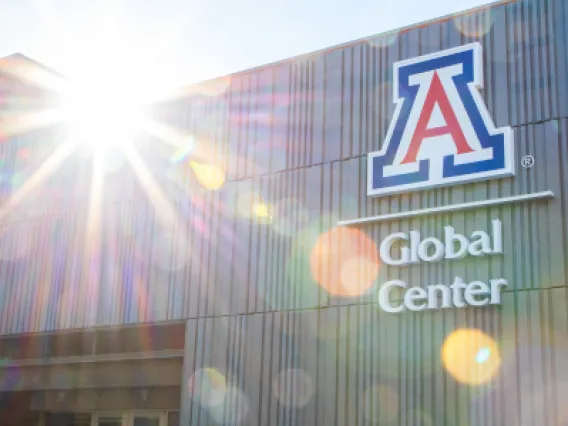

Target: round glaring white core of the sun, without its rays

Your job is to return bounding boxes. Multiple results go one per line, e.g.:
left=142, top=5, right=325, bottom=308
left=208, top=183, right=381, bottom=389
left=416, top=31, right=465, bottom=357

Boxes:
left=51, top=32, right=179, bottom=156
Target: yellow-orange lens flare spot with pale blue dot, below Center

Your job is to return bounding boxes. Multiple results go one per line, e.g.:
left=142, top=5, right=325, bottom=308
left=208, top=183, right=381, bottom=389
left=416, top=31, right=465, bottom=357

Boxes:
left=442, top=329, right=501, bottom=385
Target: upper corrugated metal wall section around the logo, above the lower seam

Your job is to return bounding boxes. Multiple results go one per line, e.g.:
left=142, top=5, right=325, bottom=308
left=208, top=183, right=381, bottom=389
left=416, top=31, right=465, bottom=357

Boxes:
left=0, top=0, right=568, bottom=333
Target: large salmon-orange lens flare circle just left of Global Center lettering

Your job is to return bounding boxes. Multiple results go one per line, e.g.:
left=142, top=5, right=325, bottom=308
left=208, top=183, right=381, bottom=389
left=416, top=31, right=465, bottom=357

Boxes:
left=310, top=228, right=379, bottom=296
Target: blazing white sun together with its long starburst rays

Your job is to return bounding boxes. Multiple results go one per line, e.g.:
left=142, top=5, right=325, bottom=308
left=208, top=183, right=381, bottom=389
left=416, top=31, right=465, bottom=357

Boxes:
left=0, top=5, right=225, bottom=228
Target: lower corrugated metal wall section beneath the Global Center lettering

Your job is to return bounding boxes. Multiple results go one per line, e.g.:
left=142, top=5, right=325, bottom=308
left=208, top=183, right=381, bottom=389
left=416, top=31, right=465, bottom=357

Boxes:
left=180, top=288, right=568, bottom=426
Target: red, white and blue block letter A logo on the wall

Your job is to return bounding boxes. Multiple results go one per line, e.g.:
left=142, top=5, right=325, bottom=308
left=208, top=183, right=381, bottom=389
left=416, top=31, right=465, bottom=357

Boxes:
left=368, top=43, right=514, bottom=195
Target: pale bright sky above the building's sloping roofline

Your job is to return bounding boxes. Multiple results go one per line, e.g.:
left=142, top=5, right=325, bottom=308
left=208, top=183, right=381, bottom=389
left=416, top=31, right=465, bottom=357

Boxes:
left=0, top=0, right=489, bottom=85
